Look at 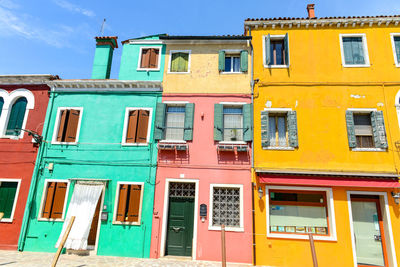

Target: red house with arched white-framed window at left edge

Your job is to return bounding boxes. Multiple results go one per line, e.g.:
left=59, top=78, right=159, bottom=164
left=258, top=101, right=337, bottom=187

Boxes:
left=0, top=75, right=58, bottom=250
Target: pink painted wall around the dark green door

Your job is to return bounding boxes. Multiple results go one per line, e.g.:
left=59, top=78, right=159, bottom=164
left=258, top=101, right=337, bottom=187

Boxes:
left=150, top=94, right=252, bottom=263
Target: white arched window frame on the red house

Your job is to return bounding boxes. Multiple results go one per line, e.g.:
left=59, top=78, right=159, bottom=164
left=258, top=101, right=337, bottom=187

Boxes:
left=0, top=88, right=35, bottom=139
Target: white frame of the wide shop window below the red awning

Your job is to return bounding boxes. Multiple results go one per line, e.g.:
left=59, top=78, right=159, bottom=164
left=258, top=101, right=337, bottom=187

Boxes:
left=265, top=185, right=337, bottom=241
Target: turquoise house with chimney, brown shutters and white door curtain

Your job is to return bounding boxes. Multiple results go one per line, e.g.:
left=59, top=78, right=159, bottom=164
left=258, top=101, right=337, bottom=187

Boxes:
left=19, top=37, right=162, bottom=257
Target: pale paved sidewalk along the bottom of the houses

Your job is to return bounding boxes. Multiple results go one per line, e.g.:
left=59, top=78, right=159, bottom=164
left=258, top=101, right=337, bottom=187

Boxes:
left=0, top=250, right=251, bottom=267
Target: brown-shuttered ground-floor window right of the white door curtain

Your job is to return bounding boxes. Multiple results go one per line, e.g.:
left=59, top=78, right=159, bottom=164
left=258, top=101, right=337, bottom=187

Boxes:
left=114, top=183, right=143, bottom=224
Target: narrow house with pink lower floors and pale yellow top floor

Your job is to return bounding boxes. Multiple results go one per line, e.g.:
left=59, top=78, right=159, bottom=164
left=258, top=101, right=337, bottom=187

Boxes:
left=150, top=36, right=253, bottom=263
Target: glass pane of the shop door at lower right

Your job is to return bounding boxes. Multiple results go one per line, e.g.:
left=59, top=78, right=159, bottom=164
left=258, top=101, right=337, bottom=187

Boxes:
left=351, top=201, right=385, bottom=266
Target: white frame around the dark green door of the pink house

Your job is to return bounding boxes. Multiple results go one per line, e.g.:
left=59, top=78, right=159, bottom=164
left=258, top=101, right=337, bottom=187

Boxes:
left=160, top=178, right=199, bottom=260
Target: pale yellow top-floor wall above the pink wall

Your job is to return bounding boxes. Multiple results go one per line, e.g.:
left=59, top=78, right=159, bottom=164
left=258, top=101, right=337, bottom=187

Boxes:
left=163, top=44, right=251, bottom=94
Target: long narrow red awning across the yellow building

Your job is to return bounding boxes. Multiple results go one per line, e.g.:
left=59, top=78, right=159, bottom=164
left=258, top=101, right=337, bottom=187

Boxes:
left=258, top=176, right=400, bottom=188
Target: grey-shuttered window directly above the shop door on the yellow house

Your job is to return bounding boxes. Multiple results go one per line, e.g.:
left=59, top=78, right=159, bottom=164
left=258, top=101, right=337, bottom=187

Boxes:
left=346, top=109, right=388, bottom=150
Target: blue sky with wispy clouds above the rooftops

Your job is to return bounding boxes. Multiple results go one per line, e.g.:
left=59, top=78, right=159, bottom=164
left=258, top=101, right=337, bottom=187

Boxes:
left=0, top=0, right=400, bottom=79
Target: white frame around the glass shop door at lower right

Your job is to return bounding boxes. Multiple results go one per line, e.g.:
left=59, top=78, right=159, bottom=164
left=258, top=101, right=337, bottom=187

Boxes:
left=347, top=191, right=397, bottom=267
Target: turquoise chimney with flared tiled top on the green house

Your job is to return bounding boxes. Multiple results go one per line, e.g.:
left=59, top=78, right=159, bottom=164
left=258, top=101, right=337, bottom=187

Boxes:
left=92, top=36, right=118, bottom=79
